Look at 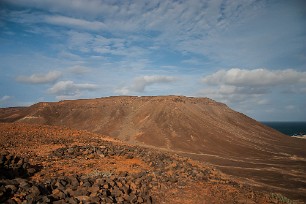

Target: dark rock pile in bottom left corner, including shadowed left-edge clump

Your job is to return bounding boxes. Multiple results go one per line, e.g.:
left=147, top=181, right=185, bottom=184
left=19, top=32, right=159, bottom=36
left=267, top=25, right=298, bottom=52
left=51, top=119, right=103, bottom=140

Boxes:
left=0, top=151, right=153, bottom=203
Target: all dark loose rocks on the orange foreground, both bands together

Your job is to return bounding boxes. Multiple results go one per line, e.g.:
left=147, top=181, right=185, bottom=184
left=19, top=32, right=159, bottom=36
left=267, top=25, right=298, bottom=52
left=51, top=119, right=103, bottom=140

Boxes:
left=0, top=141, right=218, bottom=203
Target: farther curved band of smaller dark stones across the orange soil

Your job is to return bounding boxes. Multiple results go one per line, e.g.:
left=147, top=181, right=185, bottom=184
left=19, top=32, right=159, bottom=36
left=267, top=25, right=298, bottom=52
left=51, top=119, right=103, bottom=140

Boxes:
left=51, top=142, right=213, bottom=186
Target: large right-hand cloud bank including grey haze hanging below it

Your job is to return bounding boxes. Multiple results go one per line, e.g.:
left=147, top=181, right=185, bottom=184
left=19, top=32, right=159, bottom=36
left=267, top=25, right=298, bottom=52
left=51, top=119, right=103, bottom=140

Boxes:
left=198, top=68, right=306, bottom=111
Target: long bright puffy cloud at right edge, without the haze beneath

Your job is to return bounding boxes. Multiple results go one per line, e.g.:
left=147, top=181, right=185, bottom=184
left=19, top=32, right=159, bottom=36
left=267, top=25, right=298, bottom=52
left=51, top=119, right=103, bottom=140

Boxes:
left=202, top=68, right=306, bottom=86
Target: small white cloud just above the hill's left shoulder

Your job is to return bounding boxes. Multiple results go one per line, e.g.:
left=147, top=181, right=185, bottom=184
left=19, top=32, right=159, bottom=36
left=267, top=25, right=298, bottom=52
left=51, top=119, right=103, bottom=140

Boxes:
left=48, top=81, right=98, bottom=96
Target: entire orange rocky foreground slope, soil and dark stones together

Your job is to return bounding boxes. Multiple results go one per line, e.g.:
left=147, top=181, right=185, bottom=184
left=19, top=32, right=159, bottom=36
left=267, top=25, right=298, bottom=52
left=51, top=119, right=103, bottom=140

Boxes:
left=0, top=123, right=292, bottom=203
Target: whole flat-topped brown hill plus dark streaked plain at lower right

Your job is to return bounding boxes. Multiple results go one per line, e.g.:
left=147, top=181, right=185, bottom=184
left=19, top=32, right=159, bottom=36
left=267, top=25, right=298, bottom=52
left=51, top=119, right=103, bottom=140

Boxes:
left=0, top=96, right=306, bottom=199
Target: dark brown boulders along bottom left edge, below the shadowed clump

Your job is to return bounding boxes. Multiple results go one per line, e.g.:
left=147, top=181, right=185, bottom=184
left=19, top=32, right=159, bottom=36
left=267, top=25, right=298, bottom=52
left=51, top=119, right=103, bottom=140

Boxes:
left=0, top=173, right=152, bottom=203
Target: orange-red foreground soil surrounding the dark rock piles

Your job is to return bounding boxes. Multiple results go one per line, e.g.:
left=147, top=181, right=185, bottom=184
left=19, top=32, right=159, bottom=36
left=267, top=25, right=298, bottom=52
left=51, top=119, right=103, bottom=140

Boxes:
left=0, top=123, right=296, bottom=203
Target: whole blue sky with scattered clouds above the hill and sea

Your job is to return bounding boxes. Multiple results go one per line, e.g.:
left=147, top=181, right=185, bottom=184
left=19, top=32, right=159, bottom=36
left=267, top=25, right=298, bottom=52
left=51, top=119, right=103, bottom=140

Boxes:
left=0, top=0, right=306, bottom=121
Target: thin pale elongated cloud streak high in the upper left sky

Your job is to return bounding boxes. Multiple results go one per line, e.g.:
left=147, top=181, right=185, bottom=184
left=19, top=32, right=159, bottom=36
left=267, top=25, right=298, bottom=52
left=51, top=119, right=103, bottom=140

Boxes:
left=44, top=16, right=105, bottom=30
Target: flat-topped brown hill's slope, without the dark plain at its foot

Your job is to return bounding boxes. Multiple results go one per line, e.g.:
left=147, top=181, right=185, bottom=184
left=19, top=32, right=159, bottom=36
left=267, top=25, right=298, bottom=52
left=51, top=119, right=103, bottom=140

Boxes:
left=0, top=96, right=306, bottom=156
